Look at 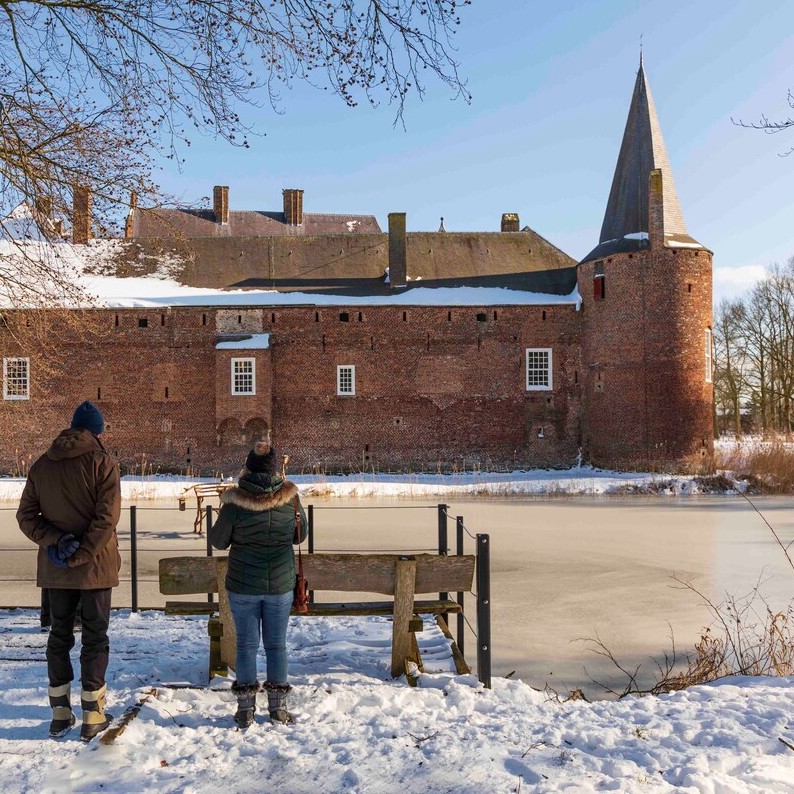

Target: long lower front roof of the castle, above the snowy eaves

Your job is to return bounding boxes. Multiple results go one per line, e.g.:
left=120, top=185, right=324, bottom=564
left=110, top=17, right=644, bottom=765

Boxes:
left=113, top=230, right=576, bottom=295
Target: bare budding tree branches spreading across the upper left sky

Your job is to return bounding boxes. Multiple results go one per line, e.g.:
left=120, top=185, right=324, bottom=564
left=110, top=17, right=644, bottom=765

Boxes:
left=0, top=0, right=471, bottom=235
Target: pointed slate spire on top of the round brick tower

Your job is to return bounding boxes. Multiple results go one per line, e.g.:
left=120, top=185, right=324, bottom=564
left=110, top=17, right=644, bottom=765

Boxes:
left=600, top=57, right=688, bottom=244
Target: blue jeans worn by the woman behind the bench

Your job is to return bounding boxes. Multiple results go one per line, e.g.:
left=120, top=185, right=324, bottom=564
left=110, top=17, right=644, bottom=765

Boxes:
left=229, top=590, right=292, bottom=685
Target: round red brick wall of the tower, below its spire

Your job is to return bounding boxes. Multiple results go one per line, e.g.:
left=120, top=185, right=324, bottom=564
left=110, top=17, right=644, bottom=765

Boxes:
left=579, top=245, right=713, bottom=469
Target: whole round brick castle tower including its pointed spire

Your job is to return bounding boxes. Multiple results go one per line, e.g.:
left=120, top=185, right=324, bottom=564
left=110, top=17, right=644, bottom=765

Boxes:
left=577, top=59, right=713, bottom=470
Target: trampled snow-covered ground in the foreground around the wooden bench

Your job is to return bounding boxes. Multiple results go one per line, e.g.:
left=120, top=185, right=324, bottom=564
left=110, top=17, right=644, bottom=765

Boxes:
left=0, top=610, right=794, bottom=794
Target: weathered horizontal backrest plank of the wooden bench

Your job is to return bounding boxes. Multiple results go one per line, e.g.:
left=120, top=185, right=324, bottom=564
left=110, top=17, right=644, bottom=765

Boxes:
left=160, top=554, right=475, bottom=595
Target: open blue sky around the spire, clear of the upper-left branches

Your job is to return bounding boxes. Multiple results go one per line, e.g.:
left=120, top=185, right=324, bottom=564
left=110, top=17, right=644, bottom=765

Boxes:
left=153, top=0, right=794, bottom=299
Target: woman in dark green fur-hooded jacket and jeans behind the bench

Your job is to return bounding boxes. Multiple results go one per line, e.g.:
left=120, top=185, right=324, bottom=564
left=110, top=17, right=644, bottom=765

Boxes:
left=209, top=442, right=307, bottom=728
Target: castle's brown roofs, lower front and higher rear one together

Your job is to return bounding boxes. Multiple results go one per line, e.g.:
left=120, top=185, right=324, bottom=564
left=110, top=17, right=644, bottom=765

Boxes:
left=111, top=186, right=576, bottom=296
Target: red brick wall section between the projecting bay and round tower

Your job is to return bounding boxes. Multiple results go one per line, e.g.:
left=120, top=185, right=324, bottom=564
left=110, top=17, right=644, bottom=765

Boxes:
left=272, top=306, right=579, bottom=470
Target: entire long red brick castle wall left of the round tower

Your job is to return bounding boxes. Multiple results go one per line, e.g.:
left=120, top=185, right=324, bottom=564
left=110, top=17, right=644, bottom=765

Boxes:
left=0, top=306, right=581, bottom=474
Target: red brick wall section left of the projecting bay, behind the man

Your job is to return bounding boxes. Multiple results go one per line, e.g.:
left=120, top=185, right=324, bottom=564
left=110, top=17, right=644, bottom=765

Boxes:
left=0, top=309, right=216, bottom=471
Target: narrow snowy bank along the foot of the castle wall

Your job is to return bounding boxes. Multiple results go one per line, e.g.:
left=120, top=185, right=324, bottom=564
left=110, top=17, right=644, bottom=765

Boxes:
left=0, top=466, right=740, bottom=502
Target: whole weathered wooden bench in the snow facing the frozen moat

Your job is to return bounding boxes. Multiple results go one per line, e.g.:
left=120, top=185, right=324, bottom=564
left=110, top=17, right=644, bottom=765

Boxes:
left=160, top=554, right=475, bottom=680
